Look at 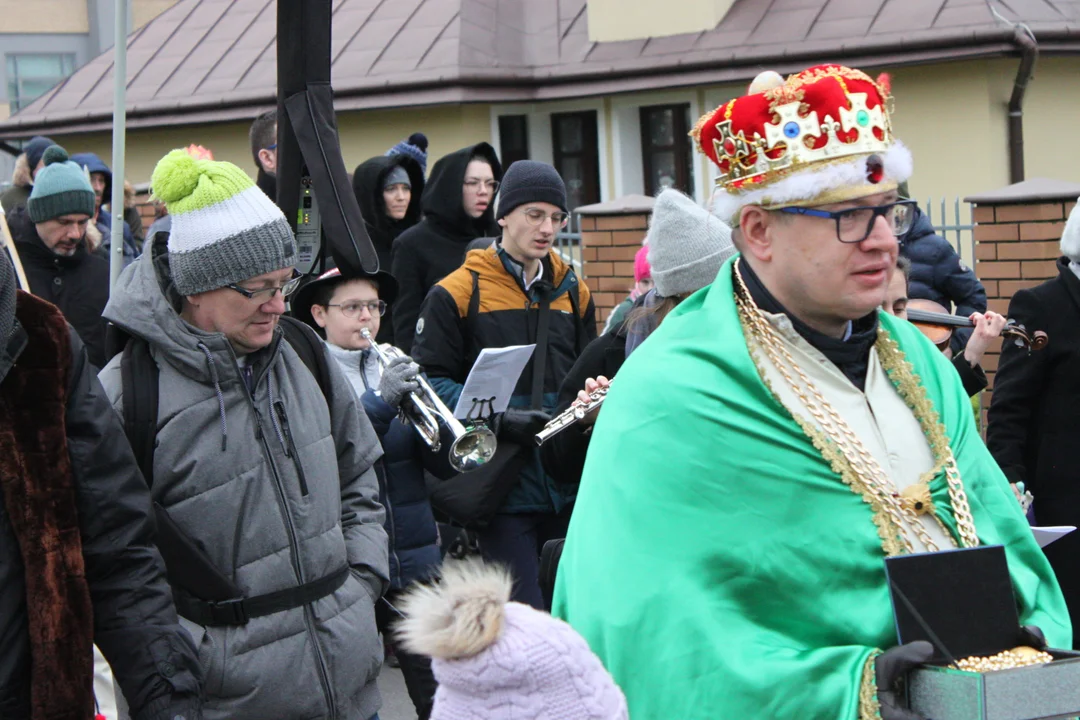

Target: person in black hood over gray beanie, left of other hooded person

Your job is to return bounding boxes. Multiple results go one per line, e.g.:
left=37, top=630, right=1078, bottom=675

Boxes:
left=352, top=154, right=423, bottom=344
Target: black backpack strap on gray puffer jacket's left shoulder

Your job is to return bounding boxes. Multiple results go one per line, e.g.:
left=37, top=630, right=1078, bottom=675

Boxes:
left=120, top=337, right=158, bottom=487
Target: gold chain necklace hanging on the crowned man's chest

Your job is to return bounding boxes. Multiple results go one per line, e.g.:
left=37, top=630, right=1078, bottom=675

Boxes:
left=733, top=260, right=978, bottom=555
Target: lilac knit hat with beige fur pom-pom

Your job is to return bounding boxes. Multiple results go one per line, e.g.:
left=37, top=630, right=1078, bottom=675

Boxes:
left=397, top=560, right=629, bottom=720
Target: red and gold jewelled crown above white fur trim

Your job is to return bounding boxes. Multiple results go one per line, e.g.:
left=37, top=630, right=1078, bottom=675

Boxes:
left=690, top=65, right=893, bottom=193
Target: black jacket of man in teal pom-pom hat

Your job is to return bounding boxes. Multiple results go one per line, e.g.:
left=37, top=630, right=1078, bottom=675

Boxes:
left=9, top=208, right=109, bottom=368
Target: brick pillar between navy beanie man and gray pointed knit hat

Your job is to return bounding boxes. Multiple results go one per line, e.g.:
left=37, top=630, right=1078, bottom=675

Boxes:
left=581, top=213, right=649, bottom=331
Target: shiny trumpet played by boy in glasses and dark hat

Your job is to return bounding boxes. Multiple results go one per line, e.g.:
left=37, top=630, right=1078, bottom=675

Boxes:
left=360, top=327, right=498, bottom=473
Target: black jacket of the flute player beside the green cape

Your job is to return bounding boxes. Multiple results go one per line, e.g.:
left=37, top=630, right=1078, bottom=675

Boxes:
left=540, top=325, right=626, bottom=485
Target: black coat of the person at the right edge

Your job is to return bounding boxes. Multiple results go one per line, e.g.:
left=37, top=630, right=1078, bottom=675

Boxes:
left=986, top=258, right=1080, bottom=642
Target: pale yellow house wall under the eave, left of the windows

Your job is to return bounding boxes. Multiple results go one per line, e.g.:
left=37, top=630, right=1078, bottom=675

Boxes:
left=50, top=105, right=491, bottom=185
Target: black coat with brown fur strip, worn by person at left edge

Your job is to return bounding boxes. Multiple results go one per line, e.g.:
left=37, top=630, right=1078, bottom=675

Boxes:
left=0, top=313, right=202, bottom=720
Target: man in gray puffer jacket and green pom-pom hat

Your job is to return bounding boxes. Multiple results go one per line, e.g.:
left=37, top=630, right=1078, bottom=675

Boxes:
left=100, top=151, right=388, bottom=720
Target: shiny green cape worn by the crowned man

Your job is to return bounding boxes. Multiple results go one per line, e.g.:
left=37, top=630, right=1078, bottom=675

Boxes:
left=554, top=261, right=1071, bottom=720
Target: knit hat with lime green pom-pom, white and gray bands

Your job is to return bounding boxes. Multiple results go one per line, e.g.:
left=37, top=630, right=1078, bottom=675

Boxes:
left=150, top=150, right=296, bottom=296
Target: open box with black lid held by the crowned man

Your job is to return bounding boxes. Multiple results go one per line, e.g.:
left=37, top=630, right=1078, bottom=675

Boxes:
left=886, top=546, right=1080, bottom=720
